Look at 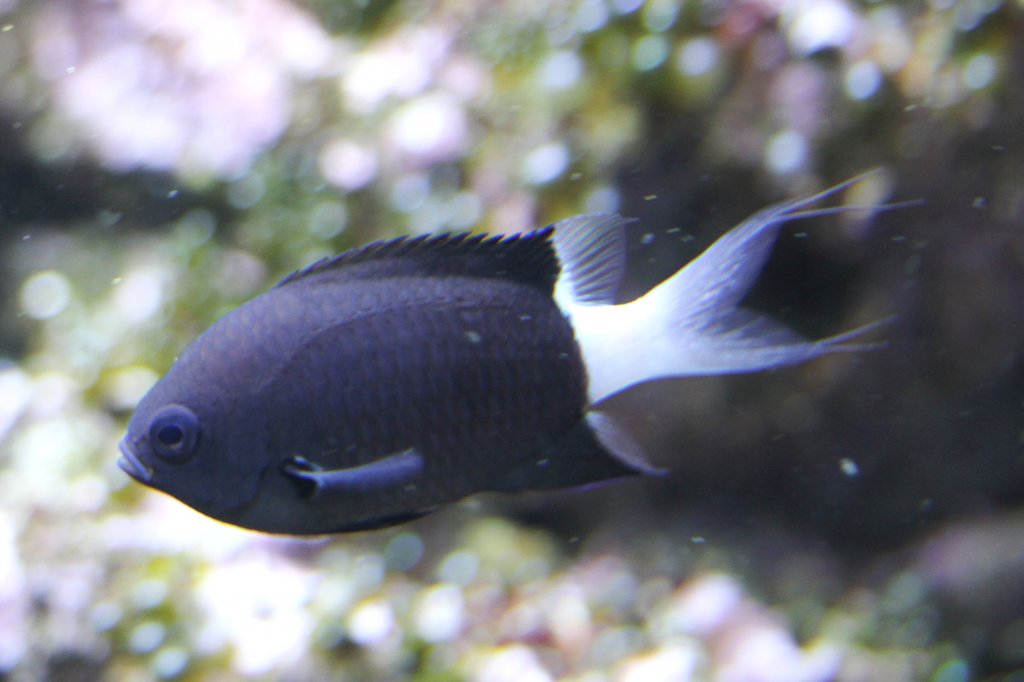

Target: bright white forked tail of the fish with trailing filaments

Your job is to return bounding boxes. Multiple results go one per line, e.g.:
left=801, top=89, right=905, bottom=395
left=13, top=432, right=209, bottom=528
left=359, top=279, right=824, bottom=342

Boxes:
left=555, top=169, right=911, bottom=403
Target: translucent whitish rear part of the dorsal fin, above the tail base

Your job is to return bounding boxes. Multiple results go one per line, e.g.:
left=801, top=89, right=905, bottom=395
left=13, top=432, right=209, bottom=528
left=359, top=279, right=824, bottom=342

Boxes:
left=554, top=213, right=635, bottom=310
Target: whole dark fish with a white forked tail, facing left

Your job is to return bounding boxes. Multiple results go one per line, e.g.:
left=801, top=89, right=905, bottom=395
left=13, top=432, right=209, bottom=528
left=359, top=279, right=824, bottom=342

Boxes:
left=118, top=176, right=898, bottom=536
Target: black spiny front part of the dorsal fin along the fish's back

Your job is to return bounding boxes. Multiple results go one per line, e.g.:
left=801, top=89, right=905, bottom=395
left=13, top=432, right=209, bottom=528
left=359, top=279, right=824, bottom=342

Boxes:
left=278, top=227, right=559, bottom=295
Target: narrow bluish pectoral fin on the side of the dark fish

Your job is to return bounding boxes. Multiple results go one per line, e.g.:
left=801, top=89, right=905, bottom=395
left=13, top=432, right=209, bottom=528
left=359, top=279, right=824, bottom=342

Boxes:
left=282, top=447, right=423, bottom=498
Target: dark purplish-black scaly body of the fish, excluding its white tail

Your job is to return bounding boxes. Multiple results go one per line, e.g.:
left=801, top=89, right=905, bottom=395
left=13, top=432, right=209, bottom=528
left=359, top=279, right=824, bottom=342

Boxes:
left=123, top=230, right=634, bottom=532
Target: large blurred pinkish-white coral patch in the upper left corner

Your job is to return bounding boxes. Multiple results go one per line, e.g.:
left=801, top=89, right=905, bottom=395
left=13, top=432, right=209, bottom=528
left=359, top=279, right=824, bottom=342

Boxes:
left=29, top=0, right=333, bottom=177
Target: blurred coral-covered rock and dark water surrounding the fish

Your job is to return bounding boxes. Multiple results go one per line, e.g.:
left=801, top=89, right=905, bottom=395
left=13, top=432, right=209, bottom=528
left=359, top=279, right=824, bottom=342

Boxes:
left=0, top=0, right=1024, bottom=682
